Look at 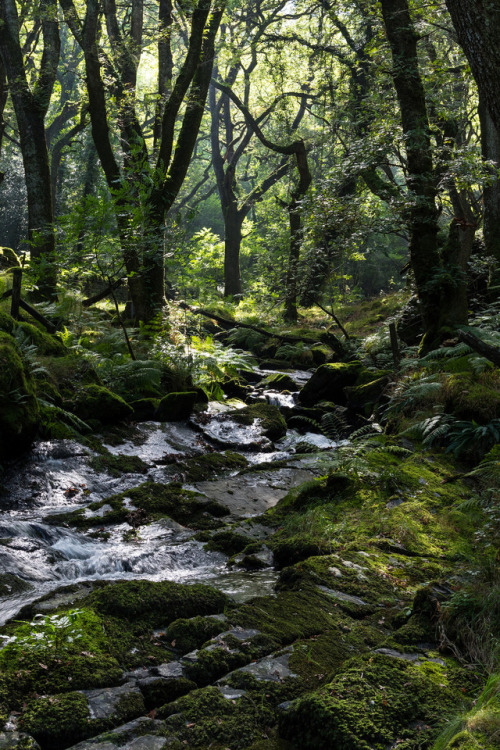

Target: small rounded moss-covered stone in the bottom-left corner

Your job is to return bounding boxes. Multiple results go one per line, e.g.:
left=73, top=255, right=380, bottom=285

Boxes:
left=19, top=692, right=92, bottom=750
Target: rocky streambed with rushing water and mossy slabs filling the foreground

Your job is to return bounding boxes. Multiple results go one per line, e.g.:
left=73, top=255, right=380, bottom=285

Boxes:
left=0, top=368, right=486, bottom=750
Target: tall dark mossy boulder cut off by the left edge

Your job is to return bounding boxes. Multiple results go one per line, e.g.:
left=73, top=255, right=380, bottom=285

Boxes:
left=0, top=333, right=40, bottom=457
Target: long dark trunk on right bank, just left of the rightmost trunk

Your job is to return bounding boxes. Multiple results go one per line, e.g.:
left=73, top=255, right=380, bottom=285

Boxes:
left=381, top=0, right=441, bottom=345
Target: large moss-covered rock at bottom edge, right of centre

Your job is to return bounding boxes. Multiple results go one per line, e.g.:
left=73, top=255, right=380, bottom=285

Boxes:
left=280, top=654, right=463, bottom=750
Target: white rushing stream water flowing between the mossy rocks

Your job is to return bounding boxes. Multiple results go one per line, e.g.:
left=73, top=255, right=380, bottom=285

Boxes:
left=0, top=373, right=336, bottom=624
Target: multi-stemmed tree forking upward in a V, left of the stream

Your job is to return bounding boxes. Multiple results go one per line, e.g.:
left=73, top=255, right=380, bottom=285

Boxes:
left=61, top=0, right=224, bottom=321
